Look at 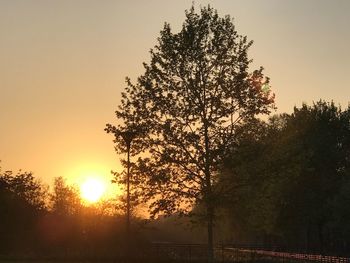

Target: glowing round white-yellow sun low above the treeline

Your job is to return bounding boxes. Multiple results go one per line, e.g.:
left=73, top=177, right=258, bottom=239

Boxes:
left=80, top=178, right=106, bottom=203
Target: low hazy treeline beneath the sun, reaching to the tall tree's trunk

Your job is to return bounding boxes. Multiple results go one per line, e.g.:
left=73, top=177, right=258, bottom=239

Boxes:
left=0, top=169, right=205, bottom=261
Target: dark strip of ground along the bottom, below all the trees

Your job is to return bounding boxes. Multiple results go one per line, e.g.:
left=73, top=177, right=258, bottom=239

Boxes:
left=0, top=243, right=350, bottom=263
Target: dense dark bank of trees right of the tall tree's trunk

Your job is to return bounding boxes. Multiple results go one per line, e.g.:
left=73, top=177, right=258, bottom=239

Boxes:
left=216, top=101, right=350, bottom=254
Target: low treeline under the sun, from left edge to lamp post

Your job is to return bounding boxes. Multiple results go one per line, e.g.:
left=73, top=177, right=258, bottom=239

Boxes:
left=0, top=171, right=130, bottom=257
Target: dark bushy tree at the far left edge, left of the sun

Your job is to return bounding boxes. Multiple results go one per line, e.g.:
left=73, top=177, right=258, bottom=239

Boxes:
left=0, top=169, right=47, bottom=254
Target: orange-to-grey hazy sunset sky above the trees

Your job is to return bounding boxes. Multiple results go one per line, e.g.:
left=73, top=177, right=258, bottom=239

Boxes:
left=0, top=0, right=350, bottom=192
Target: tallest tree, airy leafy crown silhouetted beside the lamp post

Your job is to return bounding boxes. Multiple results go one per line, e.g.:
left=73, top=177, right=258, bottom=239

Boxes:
left=107, top=6, right=274, bottom=257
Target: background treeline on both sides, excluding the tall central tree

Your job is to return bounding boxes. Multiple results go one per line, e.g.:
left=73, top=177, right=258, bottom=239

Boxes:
left=0, top=101, right=350, bottom=257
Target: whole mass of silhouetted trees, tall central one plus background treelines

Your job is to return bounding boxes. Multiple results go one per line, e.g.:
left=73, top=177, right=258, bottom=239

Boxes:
left=0, top=3, right=350, bottom=260
